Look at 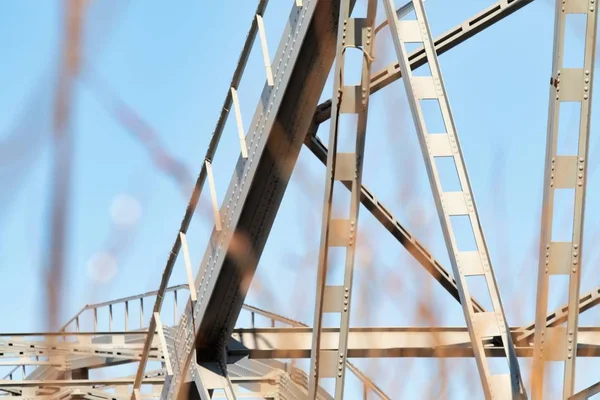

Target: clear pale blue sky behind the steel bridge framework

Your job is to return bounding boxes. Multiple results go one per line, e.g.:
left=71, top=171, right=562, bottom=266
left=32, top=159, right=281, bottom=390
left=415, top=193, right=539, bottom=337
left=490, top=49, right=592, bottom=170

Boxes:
left=0, top=0, right=600, bottom=399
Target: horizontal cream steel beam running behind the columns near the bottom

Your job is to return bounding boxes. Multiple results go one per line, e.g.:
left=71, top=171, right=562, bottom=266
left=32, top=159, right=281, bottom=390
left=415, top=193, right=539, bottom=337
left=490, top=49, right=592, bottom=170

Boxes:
left=228, top=327, right=600, bottom=359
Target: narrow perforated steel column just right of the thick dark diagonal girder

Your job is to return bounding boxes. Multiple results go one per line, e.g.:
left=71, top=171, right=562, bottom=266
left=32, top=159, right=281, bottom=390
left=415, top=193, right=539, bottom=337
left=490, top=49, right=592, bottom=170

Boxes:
left=308, top=0, right=377, bottom=399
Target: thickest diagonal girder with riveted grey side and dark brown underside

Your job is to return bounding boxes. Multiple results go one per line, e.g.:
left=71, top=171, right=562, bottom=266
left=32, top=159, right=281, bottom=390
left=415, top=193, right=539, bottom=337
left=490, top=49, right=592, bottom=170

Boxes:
left=164, top=0, right=352, bottom=398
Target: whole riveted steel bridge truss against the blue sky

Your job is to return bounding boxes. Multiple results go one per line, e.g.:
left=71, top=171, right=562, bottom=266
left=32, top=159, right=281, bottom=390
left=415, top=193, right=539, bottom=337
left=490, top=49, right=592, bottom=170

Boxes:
left=0, top=0, right=600, bottom=400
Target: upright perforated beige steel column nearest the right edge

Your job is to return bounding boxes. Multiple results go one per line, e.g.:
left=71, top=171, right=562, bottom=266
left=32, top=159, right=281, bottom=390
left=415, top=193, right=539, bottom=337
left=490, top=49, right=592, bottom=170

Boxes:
left=532, top=0, right=598, bottom=400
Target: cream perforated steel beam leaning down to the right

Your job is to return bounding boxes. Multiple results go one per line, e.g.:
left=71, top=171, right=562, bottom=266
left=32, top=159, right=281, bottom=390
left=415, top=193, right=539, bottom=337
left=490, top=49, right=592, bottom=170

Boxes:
left=383, top=0, right=526, bottom=399
